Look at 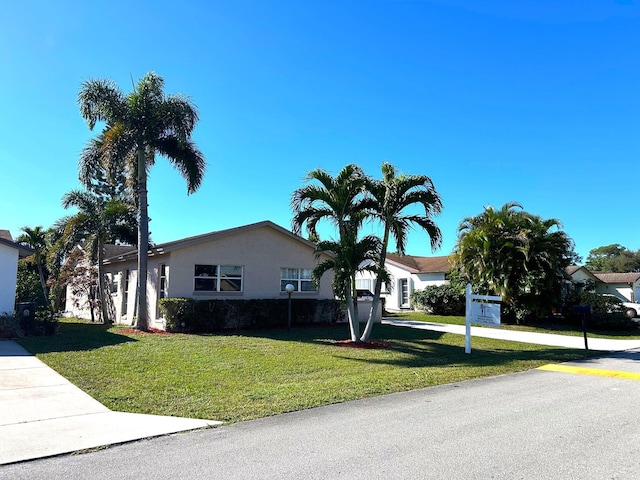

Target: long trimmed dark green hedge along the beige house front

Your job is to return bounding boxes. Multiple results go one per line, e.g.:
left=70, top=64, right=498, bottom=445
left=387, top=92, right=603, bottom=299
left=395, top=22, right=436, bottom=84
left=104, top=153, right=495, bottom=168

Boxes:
left=160, top=298, right=343, bottom=333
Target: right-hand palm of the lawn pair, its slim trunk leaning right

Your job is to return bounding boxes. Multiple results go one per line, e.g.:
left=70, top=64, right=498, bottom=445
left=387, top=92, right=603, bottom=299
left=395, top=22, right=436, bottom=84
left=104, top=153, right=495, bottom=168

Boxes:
left=361, top=162, right=442, bottom=341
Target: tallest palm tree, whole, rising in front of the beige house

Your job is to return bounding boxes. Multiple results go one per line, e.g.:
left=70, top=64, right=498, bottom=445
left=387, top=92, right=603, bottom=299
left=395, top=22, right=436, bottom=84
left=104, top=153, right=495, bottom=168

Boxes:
left=78, top=73, right=206, bottom=330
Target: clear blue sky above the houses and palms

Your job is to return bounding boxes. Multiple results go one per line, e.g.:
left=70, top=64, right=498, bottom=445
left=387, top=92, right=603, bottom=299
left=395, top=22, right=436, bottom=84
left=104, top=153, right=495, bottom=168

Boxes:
left=0, top=0, right=640, bottom=257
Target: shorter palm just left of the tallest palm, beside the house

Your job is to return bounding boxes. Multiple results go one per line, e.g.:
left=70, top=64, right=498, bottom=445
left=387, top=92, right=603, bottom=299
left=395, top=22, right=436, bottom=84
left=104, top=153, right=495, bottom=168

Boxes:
left=61, top=190, right=136, bottom=323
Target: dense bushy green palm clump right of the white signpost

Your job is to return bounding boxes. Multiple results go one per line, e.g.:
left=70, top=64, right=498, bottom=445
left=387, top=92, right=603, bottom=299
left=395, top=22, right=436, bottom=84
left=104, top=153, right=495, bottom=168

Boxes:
left=453, top=202, right=575, bottom=322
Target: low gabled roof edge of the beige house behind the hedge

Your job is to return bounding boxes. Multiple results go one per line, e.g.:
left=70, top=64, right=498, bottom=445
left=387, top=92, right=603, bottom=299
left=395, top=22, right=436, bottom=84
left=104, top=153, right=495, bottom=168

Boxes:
left=105, top=220, right=315, bottom=263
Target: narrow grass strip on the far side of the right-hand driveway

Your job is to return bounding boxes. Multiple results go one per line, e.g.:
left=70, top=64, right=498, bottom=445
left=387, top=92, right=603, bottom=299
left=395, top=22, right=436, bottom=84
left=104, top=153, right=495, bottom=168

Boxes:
left=387, top=312, right=640, bottom=340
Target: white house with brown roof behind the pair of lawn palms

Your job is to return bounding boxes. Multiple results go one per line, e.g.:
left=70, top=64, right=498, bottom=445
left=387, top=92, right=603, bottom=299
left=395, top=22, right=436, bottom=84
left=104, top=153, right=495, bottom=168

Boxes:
left=356, top=253, right=451, bottom=311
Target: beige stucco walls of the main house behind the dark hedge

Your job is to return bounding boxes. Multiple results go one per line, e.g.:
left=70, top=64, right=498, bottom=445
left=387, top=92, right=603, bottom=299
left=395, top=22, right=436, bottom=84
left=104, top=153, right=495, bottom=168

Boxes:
left=67, top=221, right=333, bottom=328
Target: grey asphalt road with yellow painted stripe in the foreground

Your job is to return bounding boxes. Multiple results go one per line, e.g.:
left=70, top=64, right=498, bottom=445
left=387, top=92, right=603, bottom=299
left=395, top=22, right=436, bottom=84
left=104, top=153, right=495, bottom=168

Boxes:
left=5, top=351, right=640, bottom=480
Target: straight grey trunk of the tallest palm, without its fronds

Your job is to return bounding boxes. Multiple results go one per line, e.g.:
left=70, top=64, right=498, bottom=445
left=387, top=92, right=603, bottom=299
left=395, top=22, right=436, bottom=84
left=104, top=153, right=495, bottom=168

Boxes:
left=136, top=143, right=149, bottom=330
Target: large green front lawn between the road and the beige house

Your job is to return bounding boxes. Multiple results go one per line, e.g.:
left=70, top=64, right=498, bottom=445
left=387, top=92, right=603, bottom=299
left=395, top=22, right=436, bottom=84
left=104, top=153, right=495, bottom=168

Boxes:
left=20, top=321, right=600, bottom=422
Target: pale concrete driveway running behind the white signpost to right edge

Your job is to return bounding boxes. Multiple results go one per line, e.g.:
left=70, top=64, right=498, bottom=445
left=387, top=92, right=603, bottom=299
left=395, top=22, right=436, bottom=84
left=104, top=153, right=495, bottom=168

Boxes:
left=382, top=318, right=640, bottom=352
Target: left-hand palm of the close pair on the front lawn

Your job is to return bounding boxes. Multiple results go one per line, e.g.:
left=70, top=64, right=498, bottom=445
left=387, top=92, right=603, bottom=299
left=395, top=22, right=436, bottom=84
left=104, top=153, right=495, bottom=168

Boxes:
left=291, top=164, right=373, bottom=341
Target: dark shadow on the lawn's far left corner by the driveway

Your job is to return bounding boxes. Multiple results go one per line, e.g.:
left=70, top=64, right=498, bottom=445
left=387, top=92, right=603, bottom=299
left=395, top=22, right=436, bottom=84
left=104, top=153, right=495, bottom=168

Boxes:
left=18, top=322, right=137, bottom=355
